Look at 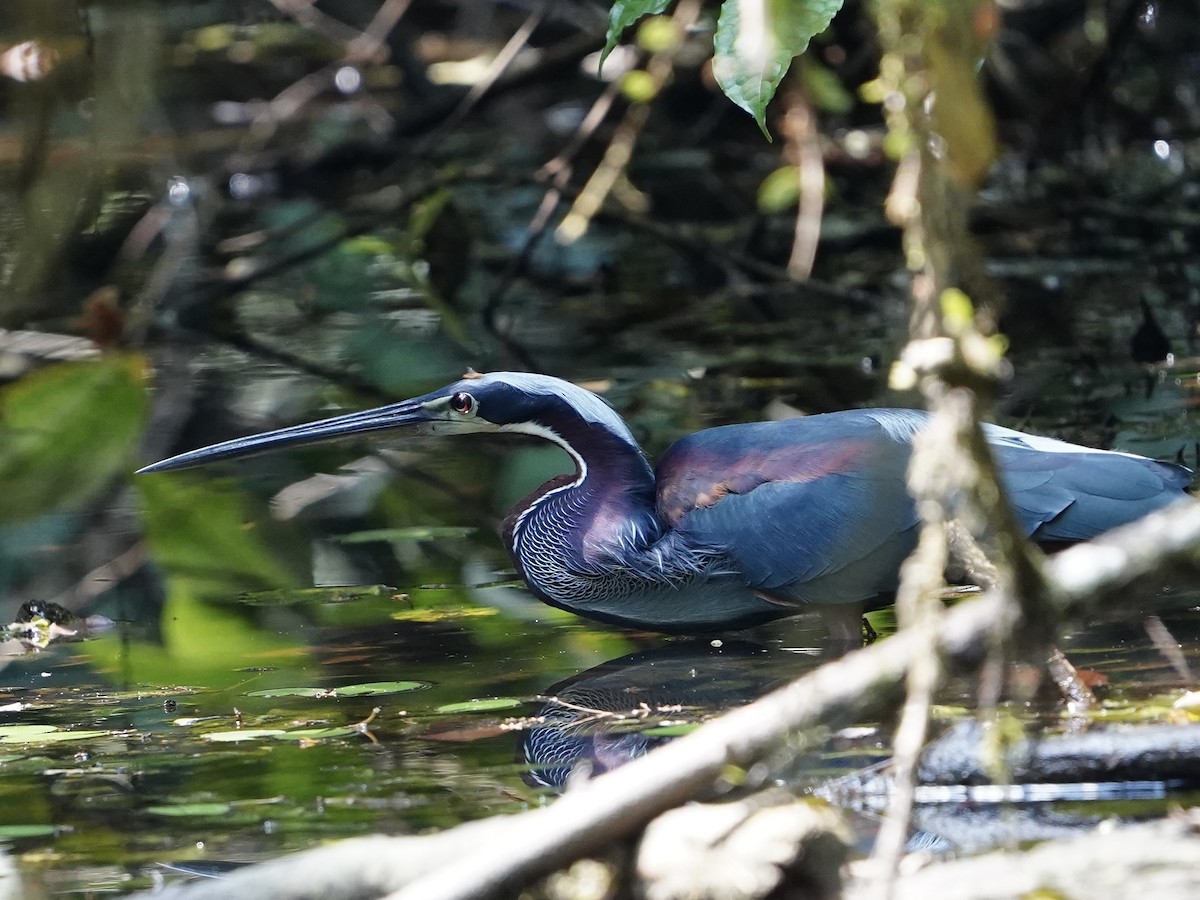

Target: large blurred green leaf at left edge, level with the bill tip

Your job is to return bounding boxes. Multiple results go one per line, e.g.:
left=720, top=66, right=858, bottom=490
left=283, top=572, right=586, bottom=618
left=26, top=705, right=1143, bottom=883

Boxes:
left=0, top=354, right=146, bottom=521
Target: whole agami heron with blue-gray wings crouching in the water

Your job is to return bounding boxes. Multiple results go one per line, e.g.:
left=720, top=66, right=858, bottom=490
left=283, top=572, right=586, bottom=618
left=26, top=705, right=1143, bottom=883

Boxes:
left=140, top=372, right=1192, bottom=632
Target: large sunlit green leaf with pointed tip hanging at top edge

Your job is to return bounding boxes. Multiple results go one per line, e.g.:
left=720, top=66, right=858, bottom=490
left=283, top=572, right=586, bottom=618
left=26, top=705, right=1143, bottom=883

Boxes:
left=713, top=0, right=842, bottom=140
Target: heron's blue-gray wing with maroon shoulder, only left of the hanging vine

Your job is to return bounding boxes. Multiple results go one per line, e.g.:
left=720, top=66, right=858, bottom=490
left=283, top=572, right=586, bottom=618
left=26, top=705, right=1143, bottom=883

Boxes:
left=658, top=410, right=923, bottom=604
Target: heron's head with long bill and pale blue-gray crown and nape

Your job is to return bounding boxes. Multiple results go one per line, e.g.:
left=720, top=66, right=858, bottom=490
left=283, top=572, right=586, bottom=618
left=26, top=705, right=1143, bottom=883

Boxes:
left=139, top=372, right=637, bottom=474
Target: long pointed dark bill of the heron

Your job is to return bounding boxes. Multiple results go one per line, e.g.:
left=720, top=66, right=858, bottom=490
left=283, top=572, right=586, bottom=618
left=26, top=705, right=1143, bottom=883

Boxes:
left=137, top=397, right=434, bottom=475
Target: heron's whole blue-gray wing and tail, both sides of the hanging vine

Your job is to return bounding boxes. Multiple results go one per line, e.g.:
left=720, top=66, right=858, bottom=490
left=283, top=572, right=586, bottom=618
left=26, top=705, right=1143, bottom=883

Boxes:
left=656, top=409, right=1192, bottom=602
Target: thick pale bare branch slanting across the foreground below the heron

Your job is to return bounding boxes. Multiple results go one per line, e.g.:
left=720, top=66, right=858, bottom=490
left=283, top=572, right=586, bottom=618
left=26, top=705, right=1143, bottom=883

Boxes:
left=136, top=502, right=1200, bottom=900
